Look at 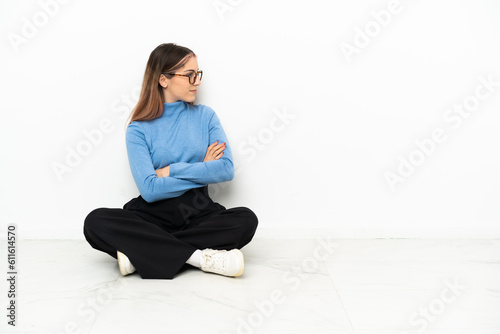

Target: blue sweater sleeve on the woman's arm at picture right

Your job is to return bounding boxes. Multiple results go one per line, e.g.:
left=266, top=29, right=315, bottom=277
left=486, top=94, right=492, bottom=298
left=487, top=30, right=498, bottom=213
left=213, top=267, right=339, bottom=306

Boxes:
left=170, top=108, right=234, bottom=184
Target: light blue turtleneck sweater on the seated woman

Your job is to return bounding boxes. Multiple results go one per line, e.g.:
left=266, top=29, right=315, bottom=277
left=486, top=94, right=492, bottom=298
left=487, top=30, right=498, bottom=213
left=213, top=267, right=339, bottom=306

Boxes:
left=126, top=101, right=234, bottom=202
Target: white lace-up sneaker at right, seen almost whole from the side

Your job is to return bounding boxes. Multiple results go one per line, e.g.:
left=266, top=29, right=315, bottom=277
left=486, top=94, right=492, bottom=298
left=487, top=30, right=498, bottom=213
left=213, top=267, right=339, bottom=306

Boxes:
left=200, top=248, right=245, bottom=277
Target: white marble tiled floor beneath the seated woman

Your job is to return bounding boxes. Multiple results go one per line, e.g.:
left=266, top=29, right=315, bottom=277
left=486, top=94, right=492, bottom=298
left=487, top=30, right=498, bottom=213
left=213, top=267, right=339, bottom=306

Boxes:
left=0, top=238, right=500, bottom=334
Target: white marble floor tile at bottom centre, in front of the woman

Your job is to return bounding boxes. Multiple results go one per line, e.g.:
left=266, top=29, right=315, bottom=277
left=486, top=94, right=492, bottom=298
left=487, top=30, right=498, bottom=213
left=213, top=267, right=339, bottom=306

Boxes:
left=92, top=286, right=350, bottom=333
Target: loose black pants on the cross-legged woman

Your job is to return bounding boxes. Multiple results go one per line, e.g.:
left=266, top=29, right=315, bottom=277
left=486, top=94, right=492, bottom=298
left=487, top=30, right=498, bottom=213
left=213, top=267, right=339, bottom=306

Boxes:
left=83, top=186, right=258, bottom=279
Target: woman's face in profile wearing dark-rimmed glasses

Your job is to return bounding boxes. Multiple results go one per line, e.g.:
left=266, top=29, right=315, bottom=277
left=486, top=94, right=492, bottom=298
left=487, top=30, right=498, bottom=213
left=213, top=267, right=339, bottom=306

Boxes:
left=159, top=57, right=200, bottom=103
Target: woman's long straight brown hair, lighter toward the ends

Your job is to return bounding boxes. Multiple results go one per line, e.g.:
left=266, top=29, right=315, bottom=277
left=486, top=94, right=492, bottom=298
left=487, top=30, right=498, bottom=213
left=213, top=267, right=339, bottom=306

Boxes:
left=128, top=43, right=196, bottom=124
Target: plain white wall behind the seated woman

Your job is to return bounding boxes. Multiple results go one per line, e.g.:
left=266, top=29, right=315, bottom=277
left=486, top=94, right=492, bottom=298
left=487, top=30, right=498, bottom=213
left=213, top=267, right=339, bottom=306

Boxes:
left=0, top=0, right=500, bottom=238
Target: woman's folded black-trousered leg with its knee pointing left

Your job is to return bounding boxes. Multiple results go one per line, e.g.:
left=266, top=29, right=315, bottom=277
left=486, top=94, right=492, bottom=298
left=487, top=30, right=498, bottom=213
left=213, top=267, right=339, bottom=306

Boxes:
left=84, top=208, right=196, bottom=279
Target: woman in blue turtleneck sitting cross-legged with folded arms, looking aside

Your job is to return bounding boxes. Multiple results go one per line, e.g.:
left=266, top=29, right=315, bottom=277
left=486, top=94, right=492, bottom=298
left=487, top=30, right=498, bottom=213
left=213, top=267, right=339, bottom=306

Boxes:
left=84, top=43, right=258, bottom=279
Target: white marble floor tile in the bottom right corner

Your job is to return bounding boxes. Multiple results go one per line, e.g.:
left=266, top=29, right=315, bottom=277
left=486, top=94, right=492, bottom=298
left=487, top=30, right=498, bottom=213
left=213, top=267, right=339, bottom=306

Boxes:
left=339, top=286, right=500, bottom=332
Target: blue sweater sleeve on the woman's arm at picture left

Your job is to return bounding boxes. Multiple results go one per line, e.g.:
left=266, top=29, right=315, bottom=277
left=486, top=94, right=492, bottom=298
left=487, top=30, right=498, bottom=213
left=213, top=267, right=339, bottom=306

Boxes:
left=126, top=123, right=204, bottom=202
